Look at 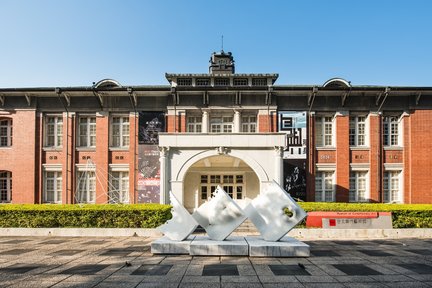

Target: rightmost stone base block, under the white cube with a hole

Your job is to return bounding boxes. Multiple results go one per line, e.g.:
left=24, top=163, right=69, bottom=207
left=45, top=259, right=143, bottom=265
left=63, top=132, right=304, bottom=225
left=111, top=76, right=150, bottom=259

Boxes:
left=245, top=236, right=310, bottom=257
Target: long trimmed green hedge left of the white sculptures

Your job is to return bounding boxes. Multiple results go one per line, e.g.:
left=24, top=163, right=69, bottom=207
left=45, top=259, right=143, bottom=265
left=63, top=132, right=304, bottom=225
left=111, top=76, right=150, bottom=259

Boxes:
left=0, top=204, right=171, bottom=228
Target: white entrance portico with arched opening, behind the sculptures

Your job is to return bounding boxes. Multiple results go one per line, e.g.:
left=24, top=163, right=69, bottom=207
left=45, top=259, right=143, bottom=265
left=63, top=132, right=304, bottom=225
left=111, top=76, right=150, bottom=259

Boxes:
left=159, top=133, right=286, bottom=208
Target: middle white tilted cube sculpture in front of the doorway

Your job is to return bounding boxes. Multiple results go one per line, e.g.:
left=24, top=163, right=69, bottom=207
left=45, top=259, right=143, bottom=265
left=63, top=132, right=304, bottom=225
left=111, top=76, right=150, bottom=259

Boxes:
left=192, top=186, right=246, bottom=241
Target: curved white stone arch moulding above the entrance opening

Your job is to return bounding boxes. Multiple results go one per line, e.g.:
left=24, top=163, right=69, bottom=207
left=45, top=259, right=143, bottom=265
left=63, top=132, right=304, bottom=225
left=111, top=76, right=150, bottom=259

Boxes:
left=175, top=149, right=270, bottom=183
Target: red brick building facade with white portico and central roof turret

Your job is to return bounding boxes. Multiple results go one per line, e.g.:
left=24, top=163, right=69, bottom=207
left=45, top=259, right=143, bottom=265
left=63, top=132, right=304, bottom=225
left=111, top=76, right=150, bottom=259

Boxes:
left=0, top=51, right=432, bottom=205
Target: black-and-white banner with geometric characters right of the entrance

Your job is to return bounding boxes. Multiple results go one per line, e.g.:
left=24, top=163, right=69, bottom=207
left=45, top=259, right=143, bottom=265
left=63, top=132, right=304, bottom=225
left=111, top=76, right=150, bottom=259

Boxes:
left=278, top=111, right=307, bottom=201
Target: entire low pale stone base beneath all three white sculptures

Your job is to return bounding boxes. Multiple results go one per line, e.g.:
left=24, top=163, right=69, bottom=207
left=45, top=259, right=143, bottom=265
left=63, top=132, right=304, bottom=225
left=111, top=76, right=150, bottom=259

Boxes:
left=151, top=236, right=310, bottom=257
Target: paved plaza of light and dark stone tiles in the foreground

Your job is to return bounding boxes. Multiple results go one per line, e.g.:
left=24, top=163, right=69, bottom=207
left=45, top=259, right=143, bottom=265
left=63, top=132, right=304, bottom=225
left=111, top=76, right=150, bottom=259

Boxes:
left=0, top=237, right=432, bottom=288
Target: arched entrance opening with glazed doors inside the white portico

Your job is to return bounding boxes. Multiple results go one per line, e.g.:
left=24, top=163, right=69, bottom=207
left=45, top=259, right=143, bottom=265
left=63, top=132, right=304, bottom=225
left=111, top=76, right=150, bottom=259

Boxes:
left=183, top=155, right=260, bottom=211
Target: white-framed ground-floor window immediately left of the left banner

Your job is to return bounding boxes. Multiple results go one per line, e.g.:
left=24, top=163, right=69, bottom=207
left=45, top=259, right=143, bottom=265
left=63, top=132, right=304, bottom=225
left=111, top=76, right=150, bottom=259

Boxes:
left=108, top=164, right=130, bottom=204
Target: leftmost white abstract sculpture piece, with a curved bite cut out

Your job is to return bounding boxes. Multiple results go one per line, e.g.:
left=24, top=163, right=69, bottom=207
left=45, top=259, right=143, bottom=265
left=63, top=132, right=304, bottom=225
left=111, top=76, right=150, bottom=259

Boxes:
left=157, top=191, right=198, bottom=241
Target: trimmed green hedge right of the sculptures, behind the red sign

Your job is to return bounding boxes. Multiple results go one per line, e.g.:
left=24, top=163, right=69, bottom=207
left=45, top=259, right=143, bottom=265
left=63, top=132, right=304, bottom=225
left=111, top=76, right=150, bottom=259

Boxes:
left=299, top=202, right=432, bottom=228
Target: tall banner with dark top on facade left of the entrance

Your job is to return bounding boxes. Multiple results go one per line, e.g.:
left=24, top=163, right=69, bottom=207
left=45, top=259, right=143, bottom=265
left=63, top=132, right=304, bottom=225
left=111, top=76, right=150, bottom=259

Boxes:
left=137, top=112, right=165, bottom=203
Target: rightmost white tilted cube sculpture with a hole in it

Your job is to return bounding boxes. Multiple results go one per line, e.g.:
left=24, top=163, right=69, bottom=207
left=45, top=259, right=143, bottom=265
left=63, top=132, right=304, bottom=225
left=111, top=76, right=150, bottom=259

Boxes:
left=244, top=181, right=307, bottom=241
